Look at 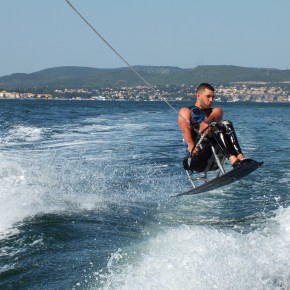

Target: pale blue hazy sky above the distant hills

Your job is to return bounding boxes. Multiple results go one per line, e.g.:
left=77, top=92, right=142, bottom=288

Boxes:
left=0, top=0, right=290, bottom=76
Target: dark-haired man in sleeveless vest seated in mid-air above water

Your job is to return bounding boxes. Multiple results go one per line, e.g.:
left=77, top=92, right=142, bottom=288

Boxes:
left=178, top=83, right=248, bottom=172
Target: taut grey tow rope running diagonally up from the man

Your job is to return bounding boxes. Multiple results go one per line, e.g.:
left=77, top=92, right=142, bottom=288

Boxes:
left=64, top=0, right=189, bottom=123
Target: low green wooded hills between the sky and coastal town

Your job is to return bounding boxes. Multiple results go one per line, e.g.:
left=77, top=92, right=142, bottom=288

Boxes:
left=0, top=65, right=290, bottom=91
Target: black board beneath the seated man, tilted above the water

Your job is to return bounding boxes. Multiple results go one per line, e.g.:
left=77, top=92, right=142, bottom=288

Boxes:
left=174, top=159, right=264, bottom=197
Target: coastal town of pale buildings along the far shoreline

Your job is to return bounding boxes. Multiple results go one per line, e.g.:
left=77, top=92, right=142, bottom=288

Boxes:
left=0, top=82, right=290, bottom=103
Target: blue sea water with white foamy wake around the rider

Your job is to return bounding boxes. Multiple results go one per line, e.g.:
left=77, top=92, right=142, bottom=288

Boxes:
left=0, top=100, right=290, bottom=290
